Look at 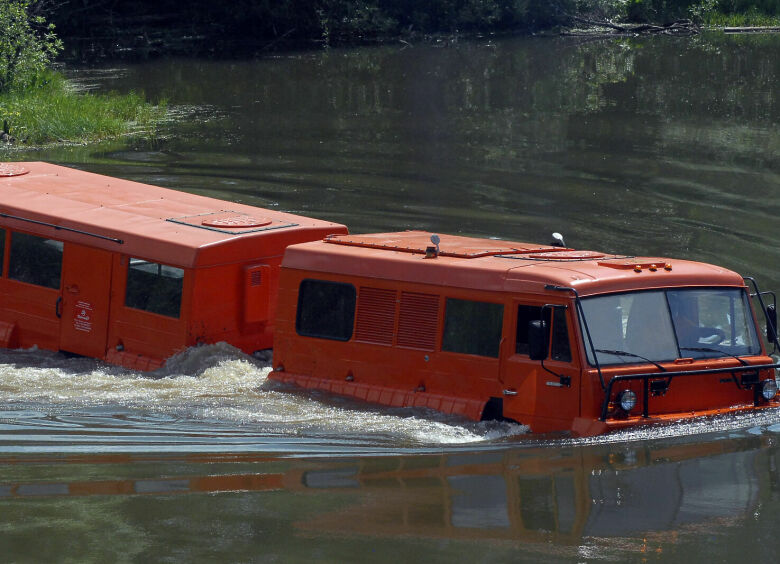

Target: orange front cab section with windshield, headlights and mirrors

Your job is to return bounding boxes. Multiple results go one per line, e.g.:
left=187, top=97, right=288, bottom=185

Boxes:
left=270, top=231, right=780, bottom=435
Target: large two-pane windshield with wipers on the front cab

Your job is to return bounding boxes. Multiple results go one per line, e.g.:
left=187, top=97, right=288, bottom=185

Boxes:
left=582, top=288, right=761, bottom=365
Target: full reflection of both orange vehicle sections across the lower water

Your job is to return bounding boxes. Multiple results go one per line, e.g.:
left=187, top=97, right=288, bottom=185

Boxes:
left=0, top=432, right=780, bottom=544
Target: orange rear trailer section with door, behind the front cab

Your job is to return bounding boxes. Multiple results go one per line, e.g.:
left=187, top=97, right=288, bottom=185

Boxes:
left=0, top=162, right=347, bottom=370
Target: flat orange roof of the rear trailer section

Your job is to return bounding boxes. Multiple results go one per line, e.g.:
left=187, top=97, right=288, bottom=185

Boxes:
left=0, top=162, right=345, bottom=267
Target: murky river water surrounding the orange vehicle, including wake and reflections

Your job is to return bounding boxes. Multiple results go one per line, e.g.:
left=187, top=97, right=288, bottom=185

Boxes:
left=0, top=34, right=780, bottom=563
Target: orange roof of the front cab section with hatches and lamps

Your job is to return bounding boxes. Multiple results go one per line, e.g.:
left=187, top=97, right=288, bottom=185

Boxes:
left=282, top=231, right=743, bottom=295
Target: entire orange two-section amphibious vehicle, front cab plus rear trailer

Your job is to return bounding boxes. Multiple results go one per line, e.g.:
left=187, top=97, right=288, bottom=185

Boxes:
left=0, top=163, right=780, bottom=435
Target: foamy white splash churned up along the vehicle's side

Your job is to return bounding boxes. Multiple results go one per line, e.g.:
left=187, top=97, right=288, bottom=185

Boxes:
left=0, top=344, right=527, bottom=448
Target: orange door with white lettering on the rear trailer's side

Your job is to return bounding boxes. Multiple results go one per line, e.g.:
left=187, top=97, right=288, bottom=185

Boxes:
left=58, top=243, right=112, bottom=359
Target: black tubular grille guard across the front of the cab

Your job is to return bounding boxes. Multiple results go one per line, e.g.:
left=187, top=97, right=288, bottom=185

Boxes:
left=600, top=364, right=780, bottom=421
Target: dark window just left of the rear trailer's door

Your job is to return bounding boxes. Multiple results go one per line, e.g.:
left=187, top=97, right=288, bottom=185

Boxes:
left=8, top=233, right=63, bottom=289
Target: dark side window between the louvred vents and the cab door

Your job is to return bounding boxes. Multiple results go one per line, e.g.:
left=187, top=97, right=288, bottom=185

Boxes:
left=441, top=298, right=504, bottom=358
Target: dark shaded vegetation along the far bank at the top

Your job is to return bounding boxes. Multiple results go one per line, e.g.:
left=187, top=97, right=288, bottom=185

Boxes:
left=41, top=0, right=780, bottom=61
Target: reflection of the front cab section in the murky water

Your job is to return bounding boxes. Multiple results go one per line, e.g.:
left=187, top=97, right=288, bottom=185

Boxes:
left=294, top=443, right=777, bottom=542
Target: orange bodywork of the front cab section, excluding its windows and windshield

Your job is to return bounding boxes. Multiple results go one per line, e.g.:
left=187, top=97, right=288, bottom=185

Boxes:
left=270, top=232, right=778, bottom=434
